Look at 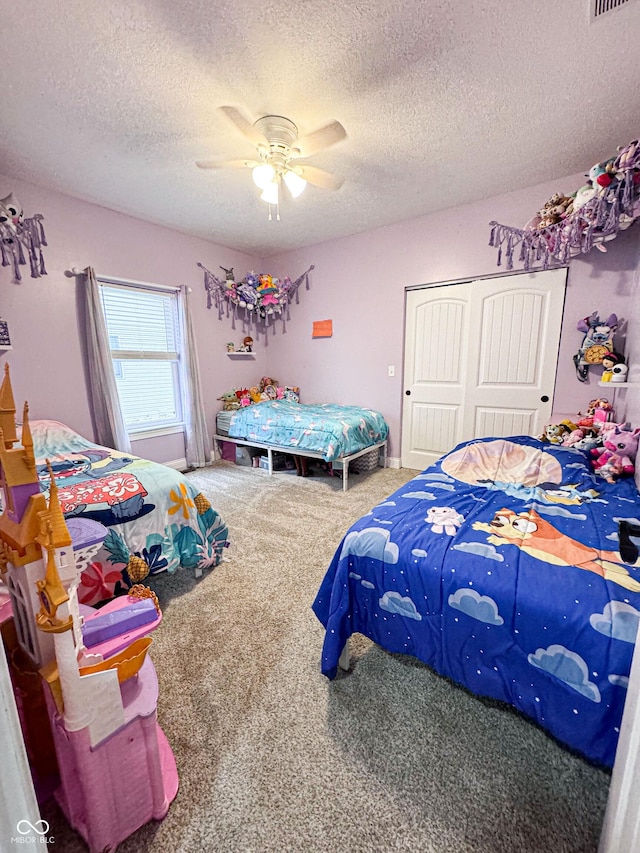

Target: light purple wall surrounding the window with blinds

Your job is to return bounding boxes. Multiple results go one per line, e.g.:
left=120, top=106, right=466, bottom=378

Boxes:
left=0, top=172, right=266, bottom=462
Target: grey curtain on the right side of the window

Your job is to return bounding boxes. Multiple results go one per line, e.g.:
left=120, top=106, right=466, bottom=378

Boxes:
left=178, top=286, right=209, bottom=468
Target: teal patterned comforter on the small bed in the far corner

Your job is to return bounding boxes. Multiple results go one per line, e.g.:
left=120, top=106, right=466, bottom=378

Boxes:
left=229, top=400, right=389, bottom=462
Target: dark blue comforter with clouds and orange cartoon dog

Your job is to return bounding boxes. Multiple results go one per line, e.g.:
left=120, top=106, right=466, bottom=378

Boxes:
left=313, top=436, right=640, bottom=766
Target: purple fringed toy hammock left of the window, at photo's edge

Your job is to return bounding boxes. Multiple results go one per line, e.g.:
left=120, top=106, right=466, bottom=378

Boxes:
left=0, top=193, right=47, bottom=281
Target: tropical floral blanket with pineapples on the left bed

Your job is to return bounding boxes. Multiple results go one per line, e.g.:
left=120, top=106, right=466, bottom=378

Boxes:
left=31, top=421, right=228, bottom=604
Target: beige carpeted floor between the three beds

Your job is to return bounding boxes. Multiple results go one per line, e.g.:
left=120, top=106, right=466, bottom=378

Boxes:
left=43, top=462, right=610, bottom=853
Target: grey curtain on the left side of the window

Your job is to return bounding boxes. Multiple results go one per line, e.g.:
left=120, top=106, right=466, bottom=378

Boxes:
left=83, top=267, right=131, bottom=453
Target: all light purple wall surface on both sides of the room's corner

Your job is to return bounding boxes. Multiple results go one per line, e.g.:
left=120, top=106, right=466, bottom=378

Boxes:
left=0, top=170, right=640, bottom=461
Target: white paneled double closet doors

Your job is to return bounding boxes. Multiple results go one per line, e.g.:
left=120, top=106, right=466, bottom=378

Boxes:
left=402, top=269, right=566, bottom=469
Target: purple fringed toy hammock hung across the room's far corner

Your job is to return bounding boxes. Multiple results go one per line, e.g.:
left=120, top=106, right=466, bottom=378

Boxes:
left=198, top=263, right=314, bottom=343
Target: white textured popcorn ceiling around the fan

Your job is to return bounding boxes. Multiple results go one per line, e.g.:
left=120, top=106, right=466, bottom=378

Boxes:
left=0, top=0, right=640, bottom=257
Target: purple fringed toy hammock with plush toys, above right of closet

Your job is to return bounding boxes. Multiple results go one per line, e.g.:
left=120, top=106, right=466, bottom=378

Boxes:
left=489, top=139, right=640, bottom=270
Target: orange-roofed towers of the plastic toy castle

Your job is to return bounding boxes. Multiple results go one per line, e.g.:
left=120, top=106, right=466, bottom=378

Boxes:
left=0, top=364, right=76, bottom=666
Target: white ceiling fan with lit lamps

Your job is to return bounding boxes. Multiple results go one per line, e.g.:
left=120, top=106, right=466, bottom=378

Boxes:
left=196, top=106, right=347, bottom=218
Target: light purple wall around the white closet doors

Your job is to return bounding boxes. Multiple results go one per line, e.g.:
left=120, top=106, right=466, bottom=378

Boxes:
left=268, top=175, right=637, bottom=456
